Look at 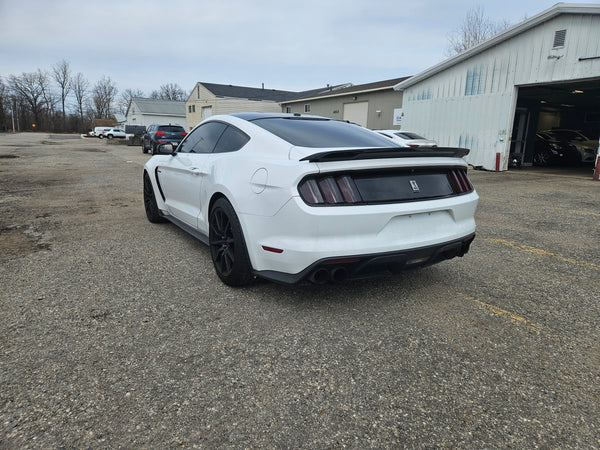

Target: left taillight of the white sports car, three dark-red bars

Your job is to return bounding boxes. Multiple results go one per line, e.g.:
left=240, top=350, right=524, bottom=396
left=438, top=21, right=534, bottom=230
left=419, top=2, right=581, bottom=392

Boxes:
left=298, top=175, right=362, bottom=205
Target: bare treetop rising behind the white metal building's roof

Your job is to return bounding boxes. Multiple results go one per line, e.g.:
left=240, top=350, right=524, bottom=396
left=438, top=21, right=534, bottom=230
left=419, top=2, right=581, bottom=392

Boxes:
left=445, top=6, right=510, bottom=56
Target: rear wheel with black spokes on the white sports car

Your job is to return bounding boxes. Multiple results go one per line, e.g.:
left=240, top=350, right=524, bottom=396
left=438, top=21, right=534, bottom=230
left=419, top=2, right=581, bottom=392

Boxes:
left=208, top=198, right=253, bottom=286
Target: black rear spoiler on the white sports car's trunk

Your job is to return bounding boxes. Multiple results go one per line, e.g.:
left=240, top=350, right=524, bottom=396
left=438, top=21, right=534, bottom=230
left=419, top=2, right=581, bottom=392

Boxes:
left=300, top=147, right=469, bottom=162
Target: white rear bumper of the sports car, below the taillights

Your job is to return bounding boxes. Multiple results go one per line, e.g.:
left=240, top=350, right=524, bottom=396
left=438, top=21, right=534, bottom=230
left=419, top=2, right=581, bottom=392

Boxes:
left=238, top=192, right=478, bottom=283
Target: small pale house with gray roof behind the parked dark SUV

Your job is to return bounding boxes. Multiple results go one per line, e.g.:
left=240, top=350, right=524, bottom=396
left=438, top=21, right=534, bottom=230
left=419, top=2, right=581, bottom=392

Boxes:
left=125, top=97, right=185, bottom=127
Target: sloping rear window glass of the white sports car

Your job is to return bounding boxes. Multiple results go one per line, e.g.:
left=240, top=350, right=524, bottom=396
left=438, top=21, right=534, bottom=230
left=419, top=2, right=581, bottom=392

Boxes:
left=252, top=118, right=395, bottom=148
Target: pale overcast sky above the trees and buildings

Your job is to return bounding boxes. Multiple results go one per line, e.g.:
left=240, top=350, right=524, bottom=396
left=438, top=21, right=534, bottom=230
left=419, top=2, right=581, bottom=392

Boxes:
left=0, top=0, right=598, bottom=94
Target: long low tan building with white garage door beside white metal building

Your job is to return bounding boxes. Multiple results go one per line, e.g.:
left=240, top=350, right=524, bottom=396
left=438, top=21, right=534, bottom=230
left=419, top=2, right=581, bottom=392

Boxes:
left=281, top=77, right=409, bottom=129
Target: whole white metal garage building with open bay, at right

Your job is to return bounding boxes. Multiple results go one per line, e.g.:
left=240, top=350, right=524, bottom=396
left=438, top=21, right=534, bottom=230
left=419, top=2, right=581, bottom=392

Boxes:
left=395, top=3, right=600, bottom=170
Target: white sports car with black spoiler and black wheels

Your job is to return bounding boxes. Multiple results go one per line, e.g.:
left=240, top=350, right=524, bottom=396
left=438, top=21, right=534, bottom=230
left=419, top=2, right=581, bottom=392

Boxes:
left=143, top=113, right=478, bottom=286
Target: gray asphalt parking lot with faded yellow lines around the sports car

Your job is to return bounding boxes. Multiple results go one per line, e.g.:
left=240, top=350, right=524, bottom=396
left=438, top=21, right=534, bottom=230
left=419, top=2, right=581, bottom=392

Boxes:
left=0, top=133, right=600, bottom=448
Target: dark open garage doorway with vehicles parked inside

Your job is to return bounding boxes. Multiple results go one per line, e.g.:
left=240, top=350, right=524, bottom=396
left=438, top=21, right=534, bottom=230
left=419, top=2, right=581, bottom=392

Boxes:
left=511, top=78, right=600, bottom=167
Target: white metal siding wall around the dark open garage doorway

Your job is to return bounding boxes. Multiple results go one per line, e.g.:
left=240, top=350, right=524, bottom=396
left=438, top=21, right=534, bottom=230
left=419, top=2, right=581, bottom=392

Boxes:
left=402, top=15, right=600, bottom=170
